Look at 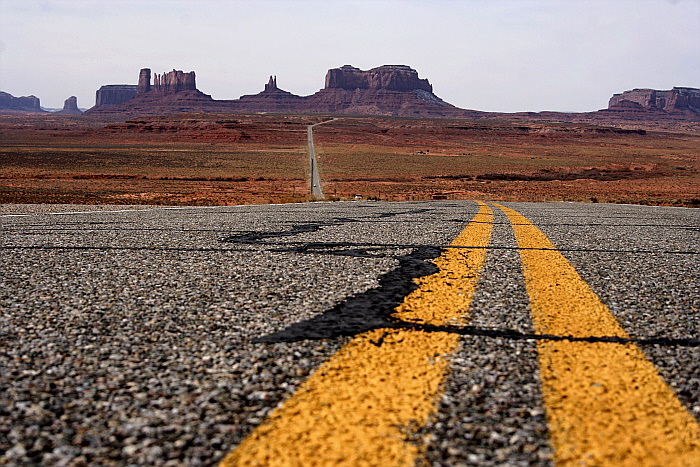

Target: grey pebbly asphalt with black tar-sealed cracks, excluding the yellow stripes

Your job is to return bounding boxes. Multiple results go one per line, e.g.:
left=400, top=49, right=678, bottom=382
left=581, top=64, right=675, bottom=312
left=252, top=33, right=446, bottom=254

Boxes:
left=0, top=201, right=700, bottom=465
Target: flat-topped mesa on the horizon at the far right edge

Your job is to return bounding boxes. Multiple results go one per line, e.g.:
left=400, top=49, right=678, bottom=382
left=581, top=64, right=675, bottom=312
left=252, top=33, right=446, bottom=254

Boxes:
left=608, top=87, right=700, bottom=113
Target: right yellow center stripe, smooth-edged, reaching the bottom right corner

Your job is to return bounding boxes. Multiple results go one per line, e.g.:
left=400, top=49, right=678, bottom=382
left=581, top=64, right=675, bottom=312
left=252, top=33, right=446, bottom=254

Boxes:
left=499, top=206, right=700, bottom=467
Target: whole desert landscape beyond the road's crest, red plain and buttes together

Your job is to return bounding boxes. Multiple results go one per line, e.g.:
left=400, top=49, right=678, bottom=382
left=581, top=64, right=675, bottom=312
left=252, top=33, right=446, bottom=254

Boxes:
left=0, top=65, right=700, bottom=206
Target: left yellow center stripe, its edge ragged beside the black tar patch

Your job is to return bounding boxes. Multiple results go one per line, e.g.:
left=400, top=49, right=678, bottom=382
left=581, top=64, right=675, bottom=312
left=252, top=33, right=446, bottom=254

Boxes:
left=220, top=203, right=493, bottom=466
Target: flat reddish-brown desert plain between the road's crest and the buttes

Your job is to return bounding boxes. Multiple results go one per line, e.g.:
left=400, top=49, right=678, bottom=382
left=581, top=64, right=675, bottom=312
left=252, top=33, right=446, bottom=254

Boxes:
left=0, top=114, right=700, bottom=206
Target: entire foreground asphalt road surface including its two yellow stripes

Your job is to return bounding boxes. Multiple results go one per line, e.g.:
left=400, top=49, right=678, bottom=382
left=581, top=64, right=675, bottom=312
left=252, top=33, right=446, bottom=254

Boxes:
left=0, top=201, right=700, bottom=466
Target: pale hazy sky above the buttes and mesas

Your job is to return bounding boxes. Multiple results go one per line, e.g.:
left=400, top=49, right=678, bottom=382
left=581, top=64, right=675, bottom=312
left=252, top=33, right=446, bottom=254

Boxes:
left=0, top=0, right=700, bottom=112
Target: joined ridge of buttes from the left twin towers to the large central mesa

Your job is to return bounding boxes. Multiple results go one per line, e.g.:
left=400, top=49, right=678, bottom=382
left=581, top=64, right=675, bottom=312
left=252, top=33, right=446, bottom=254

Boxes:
left=90, top=65, right=470, bottom=117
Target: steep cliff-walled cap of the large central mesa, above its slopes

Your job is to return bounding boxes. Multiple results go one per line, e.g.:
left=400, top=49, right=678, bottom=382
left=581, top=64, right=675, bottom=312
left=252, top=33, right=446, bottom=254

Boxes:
left=325, top=65, right=433, bottom=93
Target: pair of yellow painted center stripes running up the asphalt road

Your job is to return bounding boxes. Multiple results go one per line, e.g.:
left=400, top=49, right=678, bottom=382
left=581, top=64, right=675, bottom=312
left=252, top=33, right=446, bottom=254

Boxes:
left=221, top=203, right=700, bottom=466
